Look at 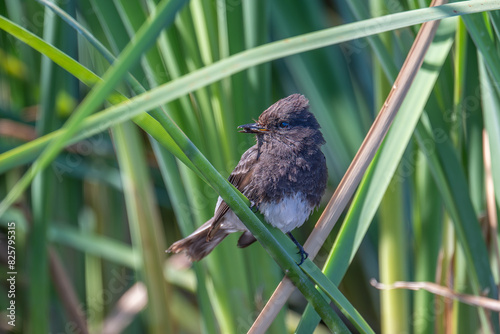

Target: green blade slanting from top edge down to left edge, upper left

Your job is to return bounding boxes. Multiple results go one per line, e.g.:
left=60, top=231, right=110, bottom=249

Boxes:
left=0, top=0, right=187, bottom=216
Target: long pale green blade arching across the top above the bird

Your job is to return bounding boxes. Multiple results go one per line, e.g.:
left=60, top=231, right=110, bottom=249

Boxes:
left=0, top=0, right=500, bottom=185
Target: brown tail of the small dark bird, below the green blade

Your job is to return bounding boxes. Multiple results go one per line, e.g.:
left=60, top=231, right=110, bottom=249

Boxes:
left=167, top=219, right=229, bottom=261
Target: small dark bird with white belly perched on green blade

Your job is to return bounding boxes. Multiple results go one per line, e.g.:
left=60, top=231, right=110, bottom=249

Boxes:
left=167, top=94, right=328, bottom=263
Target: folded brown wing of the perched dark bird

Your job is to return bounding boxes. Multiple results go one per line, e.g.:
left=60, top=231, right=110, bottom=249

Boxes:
left=207, top=145, right=258, bottom=241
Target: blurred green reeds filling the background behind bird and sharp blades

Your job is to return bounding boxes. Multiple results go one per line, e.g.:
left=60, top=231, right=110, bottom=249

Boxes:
left=0, top=0, right=500, bottom=333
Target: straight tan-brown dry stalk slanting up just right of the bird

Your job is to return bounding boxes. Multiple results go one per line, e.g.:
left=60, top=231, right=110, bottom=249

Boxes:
left=249, top=0, right=447, bottom=334
